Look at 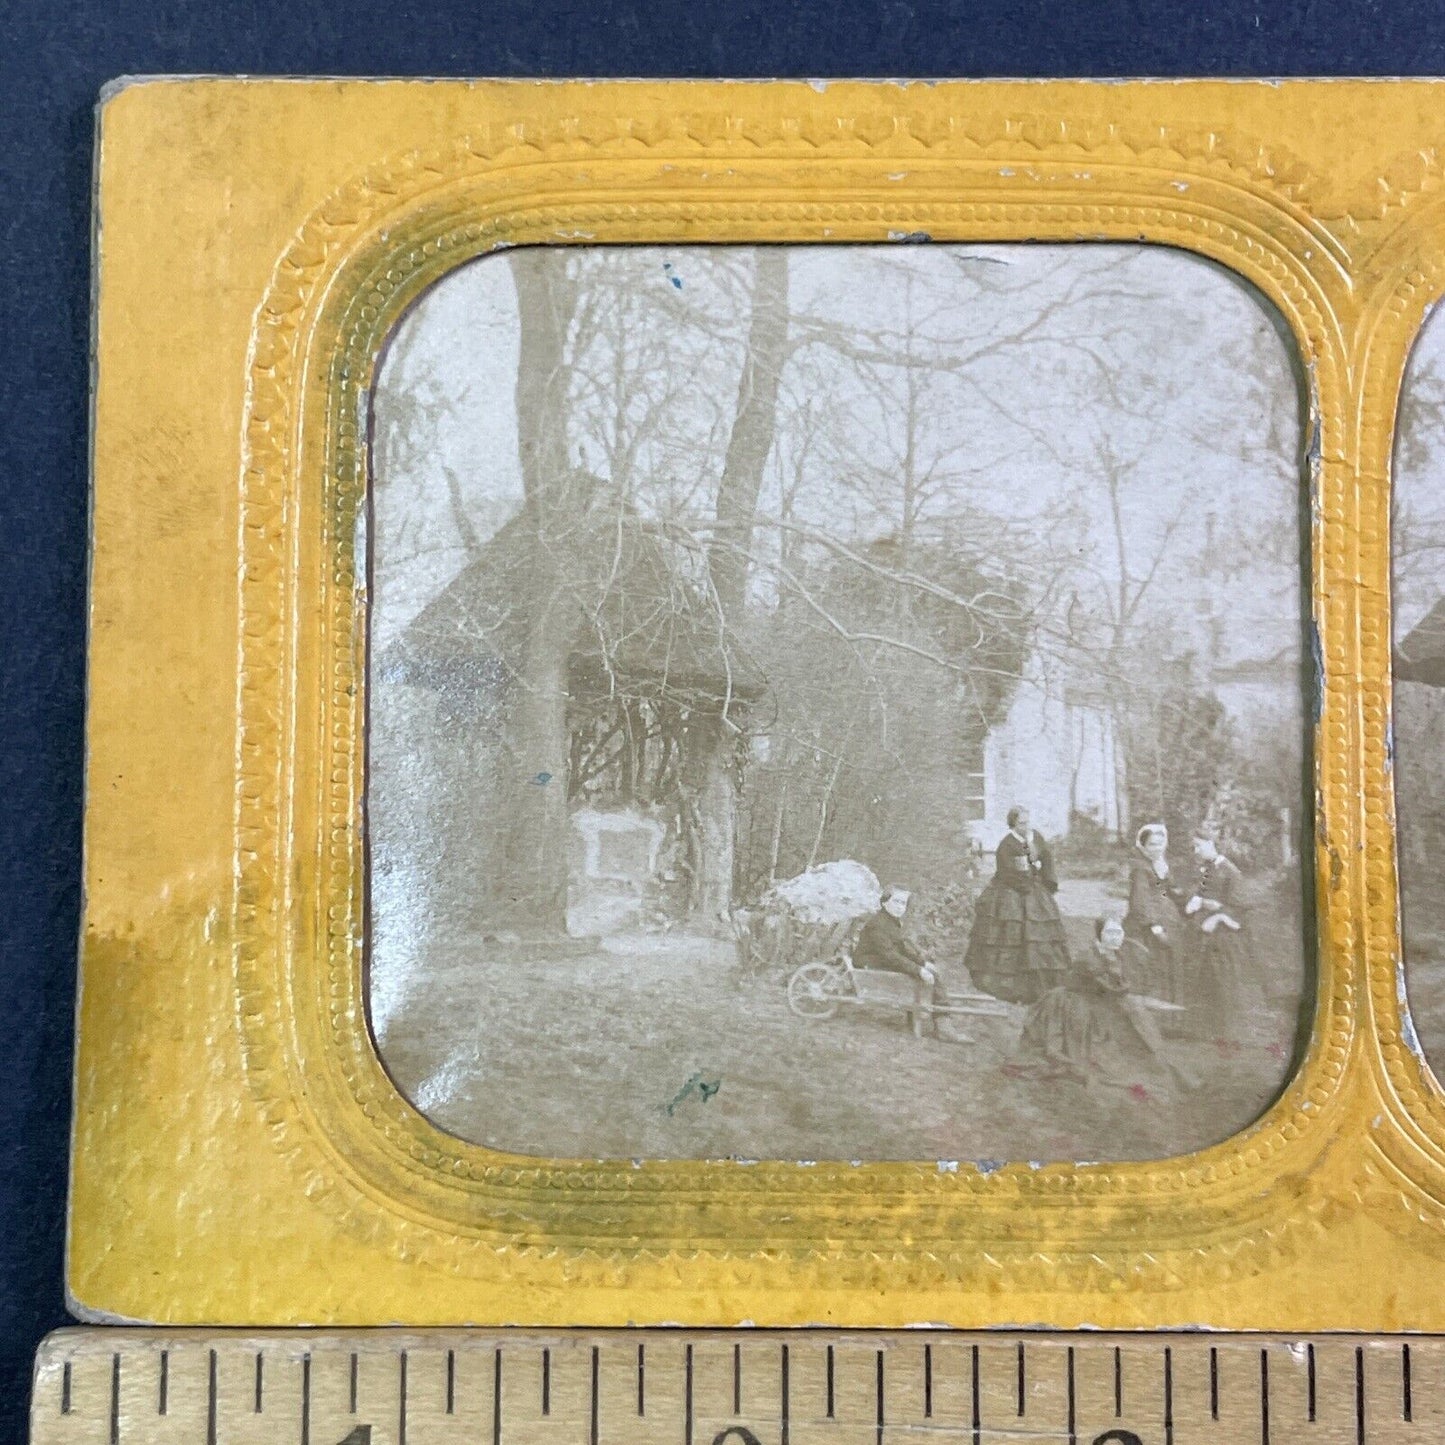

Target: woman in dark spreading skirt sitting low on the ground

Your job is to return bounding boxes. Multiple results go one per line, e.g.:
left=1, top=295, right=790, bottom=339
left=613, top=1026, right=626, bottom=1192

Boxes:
left=1004, top=918, right=1198, bottom=1088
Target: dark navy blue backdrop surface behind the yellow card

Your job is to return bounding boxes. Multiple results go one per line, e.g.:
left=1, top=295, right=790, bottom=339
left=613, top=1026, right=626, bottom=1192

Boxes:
left=0, top=0, right=1445, bottom=1441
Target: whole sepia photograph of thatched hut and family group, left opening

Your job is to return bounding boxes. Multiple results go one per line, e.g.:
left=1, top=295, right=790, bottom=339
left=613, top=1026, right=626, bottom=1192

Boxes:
left=366, top=244, right=1317, bottom=1165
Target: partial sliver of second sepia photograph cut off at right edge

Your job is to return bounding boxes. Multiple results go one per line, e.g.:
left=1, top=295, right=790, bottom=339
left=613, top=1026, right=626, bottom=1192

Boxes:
left=1390, top=304, right=1445, bottom=1074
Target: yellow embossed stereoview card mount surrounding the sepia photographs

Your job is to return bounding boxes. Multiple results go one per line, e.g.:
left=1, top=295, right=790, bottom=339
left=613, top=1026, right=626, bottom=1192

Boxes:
left=69, top=79, right=1445, bottom=1329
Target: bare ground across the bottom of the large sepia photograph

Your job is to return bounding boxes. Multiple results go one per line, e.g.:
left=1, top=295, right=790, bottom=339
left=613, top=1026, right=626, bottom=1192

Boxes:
left=379, top=935, right=1298, bottom=1160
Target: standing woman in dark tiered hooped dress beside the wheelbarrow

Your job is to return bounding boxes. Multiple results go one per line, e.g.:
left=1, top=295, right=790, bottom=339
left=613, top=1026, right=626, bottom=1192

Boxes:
left=964, top=808, right=1069, bottom=1003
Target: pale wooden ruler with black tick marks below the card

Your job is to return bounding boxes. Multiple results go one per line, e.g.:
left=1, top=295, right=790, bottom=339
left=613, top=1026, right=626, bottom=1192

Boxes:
left=30, top=1328, right=1445, bottom=1445
